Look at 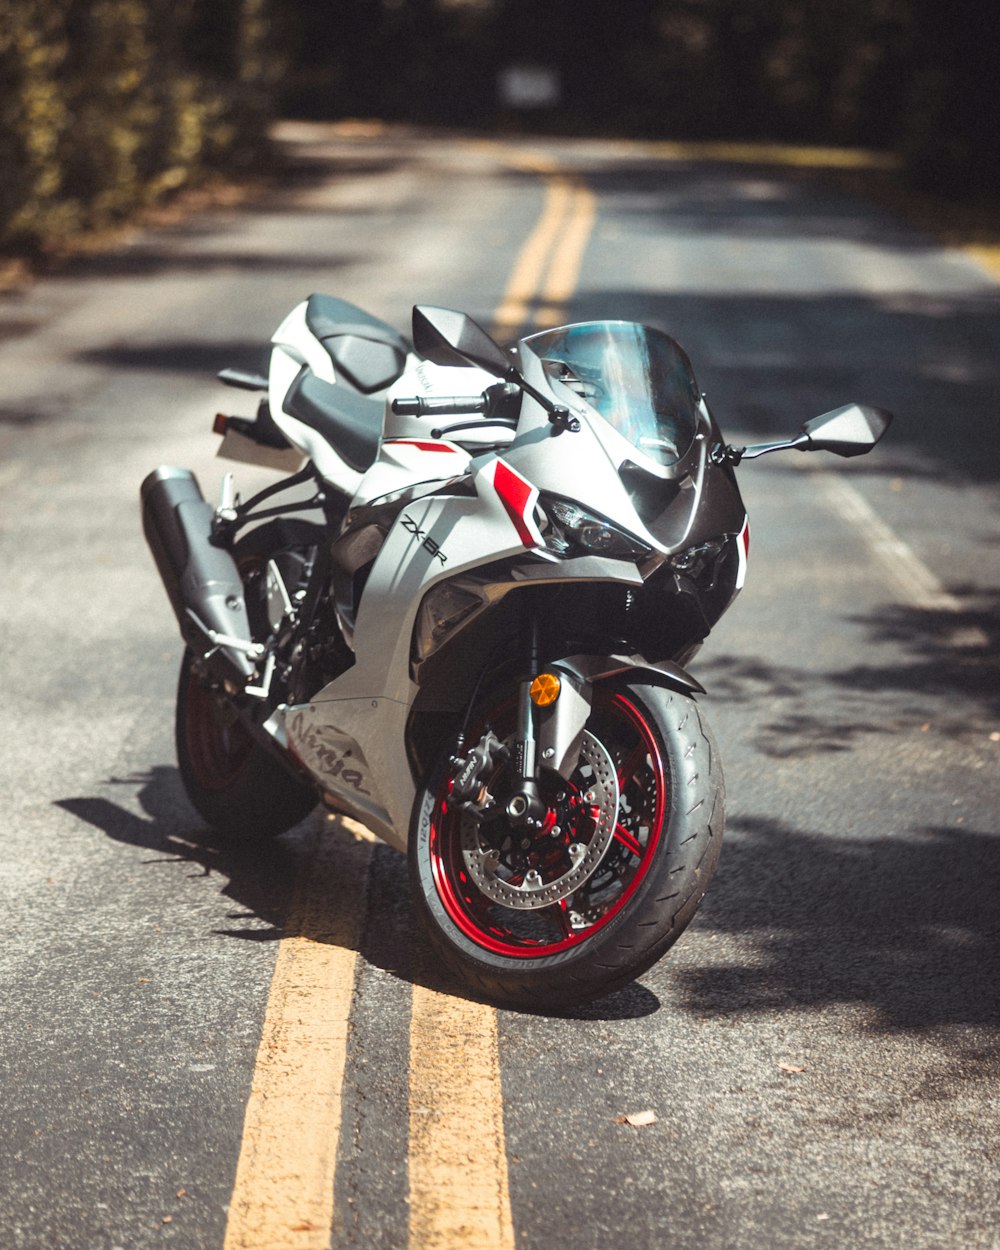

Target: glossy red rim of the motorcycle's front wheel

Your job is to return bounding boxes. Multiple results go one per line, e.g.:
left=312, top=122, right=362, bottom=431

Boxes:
left=430, top=691, right=668, bottom=959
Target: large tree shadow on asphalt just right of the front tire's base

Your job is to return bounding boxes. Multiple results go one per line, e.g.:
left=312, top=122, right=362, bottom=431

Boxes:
left=674, top=816, right=1000, bottom=1045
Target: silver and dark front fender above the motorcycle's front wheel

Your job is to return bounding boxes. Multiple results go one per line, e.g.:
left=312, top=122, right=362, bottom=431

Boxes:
left=535, top=655, right=705, bottom=780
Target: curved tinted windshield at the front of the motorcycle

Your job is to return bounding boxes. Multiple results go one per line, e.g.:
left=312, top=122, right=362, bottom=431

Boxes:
left=525, top=321, right=700, bottom=465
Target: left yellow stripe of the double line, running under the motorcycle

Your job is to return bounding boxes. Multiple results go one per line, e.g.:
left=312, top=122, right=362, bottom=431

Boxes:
left=224, top=821, right=371, bottom=1250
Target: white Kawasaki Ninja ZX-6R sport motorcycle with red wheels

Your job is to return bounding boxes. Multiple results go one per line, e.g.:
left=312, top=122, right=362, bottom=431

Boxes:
left=141, top=295, right=891, bottom=1010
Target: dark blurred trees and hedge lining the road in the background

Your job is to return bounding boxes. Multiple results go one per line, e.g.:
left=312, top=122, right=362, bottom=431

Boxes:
left=0, top=0, right=1000, bottom=270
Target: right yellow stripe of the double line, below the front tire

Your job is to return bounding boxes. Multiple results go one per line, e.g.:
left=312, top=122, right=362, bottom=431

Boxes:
left=410, top=985, right=514, bottom=1250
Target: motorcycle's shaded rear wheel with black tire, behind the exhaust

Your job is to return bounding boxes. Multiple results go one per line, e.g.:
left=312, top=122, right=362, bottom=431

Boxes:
left=175, top=521, right=319, bottom=840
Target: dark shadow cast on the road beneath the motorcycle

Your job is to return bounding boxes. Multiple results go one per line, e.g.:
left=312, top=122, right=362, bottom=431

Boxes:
left=55, top=766, right=660, bottom=1020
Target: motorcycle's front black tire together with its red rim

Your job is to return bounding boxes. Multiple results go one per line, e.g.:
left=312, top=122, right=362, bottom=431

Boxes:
left=409, top=683, right=725, bottom=1011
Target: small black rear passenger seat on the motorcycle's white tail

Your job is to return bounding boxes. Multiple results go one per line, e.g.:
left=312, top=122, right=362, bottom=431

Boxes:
left=305, top=295, right=409, bottom=395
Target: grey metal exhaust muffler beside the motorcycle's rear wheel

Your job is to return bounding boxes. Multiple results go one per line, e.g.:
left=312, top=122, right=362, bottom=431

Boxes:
left=140, top=465, right=257, bottom=684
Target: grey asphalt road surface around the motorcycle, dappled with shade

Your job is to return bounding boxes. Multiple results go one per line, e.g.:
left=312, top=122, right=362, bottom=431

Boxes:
left=0, top=128, right=1000, bottom=1250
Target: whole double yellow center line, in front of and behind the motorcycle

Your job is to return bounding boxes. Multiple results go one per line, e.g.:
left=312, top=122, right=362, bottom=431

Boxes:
left=224, top=145, right=596, bottom=1250
